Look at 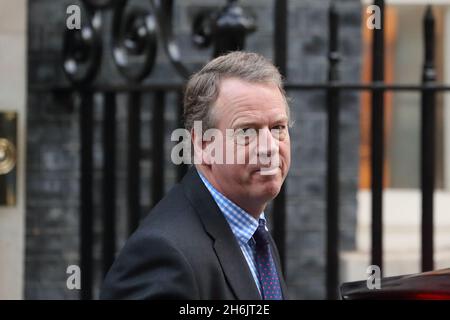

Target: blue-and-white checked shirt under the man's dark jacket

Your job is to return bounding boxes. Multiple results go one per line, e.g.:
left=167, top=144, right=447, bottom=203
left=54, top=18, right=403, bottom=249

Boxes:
left=197, top=170, right=266, bottom=293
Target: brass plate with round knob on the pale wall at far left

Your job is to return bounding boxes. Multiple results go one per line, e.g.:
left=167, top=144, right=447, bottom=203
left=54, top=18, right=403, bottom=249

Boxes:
left=0, top=111, right=17, bottom=206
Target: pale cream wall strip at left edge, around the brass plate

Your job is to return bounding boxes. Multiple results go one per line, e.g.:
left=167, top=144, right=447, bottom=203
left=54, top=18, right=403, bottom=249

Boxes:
left=0, top=0, right=27, bottom=300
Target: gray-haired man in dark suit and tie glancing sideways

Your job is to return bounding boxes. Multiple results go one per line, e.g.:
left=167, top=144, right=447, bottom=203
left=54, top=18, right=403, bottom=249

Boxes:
left=100, top=52, right=290, bottom=299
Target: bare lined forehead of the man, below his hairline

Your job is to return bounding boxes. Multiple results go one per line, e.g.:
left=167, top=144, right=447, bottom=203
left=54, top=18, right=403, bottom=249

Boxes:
left=215, top=78, right=287, bottom=124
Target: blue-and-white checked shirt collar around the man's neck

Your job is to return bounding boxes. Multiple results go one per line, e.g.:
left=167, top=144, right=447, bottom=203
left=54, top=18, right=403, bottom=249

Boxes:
left=197, top=170, right=266, bottom=244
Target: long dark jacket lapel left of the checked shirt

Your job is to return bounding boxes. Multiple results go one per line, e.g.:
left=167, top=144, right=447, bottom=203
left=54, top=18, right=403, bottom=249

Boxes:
left=181, top=167, right=261, bottom=300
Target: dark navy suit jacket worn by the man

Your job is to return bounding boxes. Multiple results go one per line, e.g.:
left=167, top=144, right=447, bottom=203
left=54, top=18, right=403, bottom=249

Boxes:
left=100, top=168, right=287, bottom=300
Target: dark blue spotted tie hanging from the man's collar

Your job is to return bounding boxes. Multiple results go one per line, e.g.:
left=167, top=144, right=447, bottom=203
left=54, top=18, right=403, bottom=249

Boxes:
left=253, top=219, right=283, bottom=300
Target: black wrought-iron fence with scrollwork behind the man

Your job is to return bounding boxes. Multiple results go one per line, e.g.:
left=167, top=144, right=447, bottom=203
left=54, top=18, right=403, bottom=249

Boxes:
left=31, top=0, right=444, bottom=299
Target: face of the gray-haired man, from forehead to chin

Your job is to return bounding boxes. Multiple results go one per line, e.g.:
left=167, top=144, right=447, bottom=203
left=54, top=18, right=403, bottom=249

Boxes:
left=205, top=78, right=291, bottom=208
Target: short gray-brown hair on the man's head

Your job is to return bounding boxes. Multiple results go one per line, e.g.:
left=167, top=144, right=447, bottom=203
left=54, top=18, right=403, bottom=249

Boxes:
left=184, top=51, right=290, bottom=131
